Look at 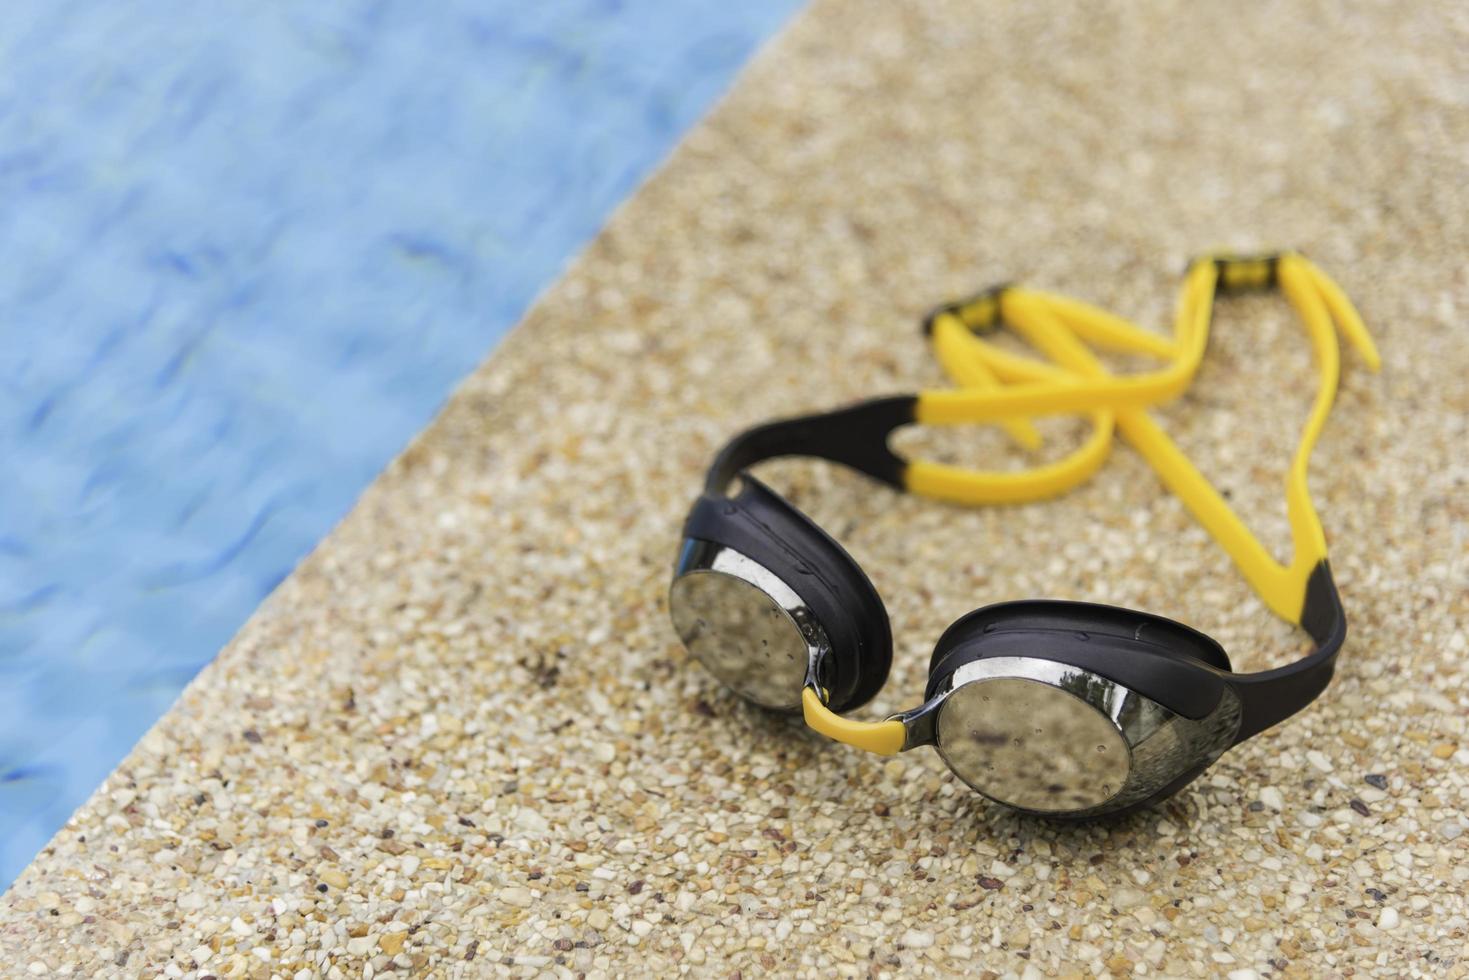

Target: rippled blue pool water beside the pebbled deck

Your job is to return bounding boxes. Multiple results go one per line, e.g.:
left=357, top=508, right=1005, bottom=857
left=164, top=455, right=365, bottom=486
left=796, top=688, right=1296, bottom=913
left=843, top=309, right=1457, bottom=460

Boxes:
left=0, top=0, right=799, bottom=887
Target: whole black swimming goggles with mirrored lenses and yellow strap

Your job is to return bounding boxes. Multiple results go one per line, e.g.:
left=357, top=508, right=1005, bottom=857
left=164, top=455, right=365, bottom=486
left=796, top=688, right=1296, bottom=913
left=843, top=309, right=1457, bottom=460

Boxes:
left=668, top=253, right=1379, bottom=818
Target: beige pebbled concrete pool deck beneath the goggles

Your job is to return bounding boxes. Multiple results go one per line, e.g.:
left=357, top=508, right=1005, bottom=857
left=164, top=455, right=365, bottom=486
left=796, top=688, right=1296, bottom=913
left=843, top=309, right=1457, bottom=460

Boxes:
left=0, top=0, right=1469, bottom=977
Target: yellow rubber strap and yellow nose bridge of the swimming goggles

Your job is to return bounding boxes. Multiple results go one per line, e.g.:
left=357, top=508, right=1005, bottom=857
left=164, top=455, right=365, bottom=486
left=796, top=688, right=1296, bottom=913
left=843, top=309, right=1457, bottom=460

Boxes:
left=804, top=253, right=1381, bottom=755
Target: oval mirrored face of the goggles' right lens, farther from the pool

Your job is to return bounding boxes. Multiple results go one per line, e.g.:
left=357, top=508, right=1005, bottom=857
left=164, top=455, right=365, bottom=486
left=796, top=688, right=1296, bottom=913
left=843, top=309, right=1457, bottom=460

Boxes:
left=939, top=677, right=1131, bottom=813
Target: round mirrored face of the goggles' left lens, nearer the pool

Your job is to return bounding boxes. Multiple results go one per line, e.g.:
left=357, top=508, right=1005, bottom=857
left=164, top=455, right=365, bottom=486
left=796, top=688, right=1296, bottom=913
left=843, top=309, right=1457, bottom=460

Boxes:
left=668, top=572, right=806, bottom=708
